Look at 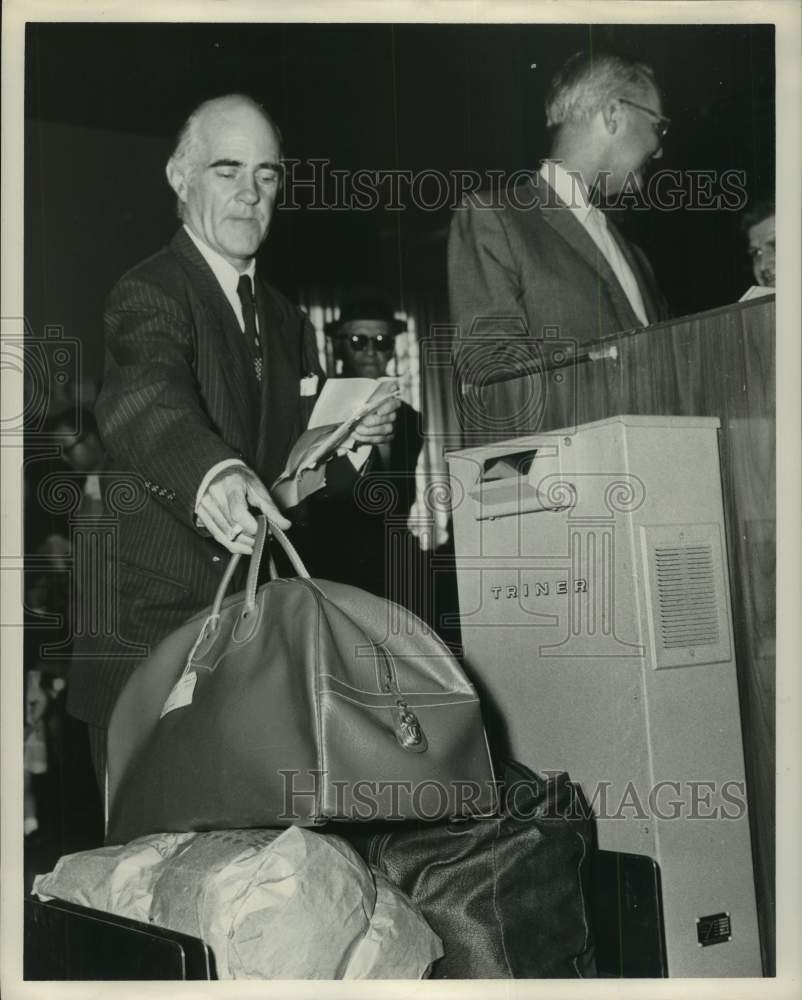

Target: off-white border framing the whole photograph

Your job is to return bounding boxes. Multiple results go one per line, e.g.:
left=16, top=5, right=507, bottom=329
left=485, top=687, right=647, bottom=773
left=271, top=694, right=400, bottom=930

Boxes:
left=0, top=0, right=802, bottom=1000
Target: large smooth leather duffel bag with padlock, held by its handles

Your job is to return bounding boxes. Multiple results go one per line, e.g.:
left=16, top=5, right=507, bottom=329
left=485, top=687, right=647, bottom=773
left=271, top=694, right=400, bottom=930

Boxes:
left=107, top=518, right=496, bottom=843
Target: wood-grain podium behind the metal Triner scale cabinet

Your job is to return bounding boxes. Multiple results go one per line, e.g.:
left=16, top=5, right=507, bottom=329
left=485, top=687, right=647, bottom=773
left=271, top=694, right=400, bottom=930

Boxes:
left=456, top=296, right=776, bottom=975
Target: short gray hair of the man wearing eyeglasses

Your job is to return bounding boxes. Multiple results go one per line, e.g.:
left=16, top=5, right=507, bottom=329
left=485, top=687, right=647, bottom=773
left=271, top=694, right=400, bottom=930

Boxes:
left=546, top=52, right=657, bottom=127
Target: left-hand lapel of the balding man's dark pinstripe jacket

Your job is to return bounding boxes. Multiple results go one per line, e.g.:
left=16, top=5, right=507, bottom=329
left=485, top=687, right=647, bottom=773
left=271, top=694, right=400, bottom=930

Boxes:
left=170, top=228, right=259, bottom=459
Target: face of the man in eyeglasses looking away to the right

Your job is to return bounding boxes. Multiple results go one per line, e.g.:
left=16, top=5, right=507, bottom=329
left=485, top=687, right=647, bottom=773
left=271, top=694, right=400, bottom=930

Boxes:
left=606, top=86, right=663, bottom=194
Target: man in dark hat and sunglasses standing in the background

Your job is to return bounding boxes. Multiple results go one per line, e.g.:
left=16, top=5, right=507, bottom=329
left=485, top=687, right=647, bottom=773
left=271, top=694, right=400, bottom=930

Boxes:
left=287, top=298, right=421, bottom=610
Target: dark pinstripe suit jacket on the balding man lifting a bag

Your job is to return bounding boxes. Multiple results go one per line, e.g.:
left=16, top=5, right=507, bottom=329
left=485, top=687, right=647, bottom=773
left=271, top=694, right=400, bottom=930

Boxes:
left=68, top=229, right=323, bottom=726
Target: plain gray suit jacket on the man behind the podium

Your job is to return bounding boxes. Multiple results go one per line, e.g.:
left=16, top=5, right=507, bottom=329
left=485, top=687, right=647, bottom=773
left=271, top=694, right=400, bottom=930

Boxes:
left=448, top=174, right=668, bottom=437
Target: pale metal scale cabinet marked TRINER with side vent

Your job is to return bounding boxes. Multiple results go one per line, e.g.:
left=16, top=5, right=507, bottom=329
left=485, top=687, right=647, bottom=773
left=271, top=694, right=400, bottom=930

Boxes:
left=447, top=416, right=761, bottom=976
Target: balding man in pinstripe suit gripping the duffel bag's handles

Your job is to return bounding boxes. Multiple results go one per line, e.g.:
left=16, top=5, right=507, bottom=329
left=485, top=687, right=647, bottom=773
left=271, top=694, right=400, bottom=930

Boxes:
left=68, top=95, right=398, bottom=781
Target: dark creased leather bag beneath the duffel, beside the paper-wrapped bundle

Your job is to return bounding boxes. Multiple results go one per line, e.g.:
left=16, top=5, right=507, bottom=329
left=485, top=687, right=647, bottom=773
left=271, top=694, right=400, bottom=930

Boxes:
left=345, top=761, right=596, bottom=979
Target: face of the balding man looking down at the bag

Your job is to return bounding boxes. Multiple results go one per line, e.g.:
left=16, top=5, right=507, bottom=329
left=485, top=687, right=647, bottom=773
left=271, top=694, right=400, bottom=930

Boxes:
left=170, top=103, right=281, bottom=271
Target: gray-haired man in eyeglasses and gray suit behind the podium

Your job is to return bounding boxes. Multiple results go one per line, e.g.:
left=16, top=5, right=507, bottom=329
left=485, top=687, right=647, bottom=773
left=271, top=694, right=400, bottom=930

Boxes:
left=448, top=52, right=670, bottom=437
